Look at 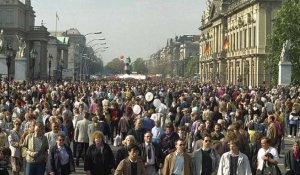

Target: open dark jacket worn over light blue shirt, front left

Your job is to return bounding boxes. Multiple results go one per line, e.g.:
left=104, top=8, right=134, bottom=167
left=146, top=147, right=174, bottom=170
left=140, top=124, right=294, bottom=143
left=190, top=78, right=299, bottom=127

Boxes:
left=47, top=144, right=75, bottom=175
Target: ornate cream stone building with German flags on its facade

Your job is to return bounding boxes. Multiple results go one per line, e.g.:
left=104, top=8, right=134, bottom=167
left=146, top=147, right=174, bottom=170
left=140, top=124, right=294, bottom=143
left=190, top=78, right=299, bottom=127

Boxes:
left=199, top=0, right=281, bottom=86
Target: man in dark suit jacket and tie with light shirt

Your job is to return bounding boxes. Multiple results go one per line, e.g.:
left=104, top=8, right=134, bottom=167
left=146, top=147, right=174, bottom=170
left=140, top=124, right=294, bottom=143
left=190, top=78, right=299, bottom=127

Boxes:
left=139, top=131, right=163, bottom=175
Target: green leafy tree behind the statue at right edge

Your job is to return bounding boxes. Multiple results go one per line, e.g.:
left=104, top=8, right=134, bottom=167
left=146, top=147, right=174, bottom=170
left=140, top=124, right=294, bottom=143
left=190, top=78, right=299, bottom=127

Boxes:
left=265, top=0, right=300, bottom=84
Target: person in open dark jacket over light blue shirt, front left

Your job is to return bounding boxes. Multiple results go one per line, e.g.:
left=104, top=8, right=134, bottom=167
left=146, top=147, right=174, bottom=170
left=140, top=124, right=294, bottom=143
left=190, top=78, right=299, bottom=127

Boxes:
left=47, top=134, right=75, bottom=175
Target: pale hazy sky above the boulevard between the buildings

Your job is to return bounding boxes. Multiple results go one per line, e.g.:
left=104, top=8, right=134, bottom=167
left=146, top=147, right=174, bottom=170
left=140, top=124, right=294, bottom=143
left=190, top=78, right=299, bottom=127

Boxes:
left=31, top=0, right=206, bottom=64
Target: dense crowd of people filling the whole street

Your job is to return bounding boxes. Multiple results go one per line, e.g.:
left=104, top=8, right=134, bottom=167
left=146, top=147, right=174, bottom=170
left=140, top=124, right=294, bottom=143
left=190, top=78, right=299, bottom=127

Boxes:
left=0, top=80, right=300, bottom=175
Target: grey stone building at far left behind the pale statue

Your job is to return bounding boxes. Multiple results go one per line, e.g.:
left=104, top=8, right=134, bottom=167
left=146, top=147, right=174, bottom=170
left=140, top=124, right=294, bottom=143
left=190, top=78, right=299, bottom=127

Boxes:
left=0, top=0, right=49, bottom=80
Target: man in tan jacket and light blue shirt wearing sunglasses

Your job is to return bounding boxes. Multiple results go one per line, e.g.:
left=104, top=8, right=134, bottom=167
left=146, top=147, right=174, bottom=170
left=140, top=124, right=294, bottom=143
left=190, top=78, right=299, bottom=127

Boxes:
left=162, top=139, right=194, bottom=175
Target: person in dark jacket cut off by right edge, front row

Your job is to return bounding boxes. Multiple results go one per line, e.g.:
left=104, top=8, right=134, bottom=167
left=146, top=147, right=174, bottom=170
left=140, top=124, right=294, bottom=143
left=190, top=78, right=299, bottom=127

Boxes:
left=284, top=141, right=300, bottom=175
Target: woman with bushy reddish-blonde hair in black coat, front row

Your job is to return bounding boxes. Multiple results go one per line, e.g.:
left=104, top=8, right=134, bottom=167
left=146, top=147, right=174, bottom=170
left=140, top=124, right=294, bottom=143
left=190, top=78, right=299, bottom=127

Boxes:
left=84, top=131, right=115, bottom=175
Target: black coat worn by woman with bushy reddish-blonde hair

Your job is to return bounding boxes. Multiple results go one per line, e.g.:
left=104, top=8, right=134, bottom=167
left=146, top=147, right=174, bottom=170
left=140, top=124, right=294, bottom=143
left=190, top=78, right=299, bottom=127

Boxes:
left=84, top=143, right=115, bottom=175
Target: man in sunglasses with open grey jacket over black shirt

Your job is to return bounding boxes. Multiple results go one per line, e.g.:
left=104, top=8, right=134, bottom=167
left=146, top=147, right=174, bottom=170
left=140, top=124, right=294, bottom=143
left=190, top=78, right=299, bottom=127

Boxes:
left=192, top=135, right=220, bottom=175
